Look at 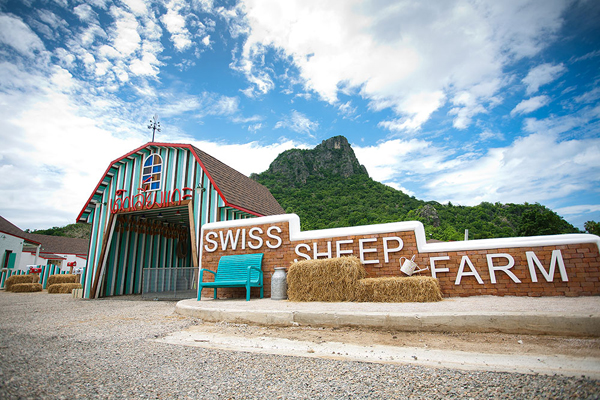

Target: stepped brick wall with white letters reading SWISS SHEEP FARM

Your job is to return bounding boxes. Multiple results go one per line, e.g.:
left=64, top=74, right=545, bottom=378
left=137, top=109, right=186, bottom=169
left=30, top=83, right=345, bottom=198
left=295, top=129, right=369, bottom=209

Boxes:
left=201, top=217, right=600, bottom=298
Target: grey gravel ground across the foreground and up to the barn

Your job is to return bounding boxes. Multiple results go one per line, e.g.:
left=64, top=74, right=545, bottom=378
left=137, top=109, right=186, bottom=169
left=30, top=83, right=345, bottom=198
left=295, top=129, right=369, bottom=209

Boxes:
left=0, top=291, right=600, bottom=399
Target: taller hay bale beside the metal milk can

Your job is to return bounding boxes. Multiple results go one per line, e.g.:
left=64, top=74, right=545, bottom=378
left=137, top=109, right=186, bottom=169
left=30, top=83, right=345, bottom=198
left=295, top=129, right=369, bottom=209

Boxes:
left=287, top=256, right=367, bottom=301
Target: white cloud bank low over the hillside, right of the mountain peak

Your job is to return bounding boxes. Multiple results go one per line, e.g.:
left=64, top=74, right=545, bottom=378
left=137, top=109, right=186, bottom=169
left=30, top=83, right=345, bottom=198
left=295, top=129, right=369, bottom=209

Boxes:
left=353, top=101, right=600, bottom=209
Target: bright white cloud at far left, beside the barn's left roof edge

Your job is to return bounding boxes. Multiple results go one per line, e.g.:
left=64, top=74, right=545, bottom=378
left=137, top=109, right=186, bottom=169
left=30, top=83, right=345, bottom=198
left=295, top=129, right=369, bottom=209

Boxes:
left=0, top=68, right=143, bottom=228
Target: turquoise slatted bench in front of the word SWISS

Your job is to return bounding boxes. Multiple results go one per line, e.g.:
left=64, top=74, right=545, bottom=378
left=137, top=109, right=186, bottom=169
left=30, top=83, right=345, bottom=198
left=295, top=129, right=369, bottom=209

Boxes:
left=198, top=253, right=263, bottom=301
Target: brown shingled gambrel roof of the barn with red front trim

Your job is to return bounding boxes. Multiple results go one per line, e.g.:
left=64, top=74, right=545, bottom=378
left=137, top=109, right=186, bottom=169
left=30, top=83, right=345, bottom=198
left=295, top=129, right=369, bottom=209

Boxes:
left=77, top=142, right=285, bottom=222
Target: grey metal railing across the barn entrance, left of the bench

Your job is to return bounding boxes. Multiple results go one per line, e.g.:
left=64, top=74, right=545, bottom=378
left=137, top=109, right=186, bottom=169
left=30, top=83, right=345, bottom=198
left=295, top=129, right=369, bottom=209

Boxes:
left=142, top=267, right=198, bottom=300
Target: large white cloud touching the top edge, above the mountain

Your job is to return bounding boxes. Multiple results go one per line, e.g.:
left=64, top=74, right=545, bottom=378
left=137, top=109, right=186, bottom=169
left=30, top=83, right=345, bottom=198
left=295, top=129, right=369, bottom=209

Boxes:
left=237, top=0, right=568, bottom=131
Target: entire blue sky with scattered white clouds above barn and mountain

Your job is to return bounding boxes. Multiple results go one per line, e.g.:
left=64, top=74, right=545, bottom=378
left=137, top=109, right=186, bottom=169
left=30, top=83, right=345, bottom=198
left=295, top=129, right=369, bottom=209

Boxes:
left=0, top=0, right=600, bottom=229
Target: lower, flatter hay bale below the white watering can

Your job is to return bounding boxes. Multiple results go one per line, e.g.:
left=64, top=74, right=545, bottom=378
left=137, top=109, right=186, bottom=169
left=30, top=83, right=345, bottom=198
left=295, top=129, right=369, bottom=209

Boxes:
left=358, top=276, right=442, bottom=303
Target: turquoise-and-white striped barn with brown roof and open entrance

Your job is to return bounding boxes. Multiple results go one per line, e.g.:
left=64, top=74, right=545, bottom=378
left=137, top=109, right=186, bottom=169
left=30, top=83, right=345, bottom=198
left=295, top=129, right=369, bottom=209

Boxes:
left=77, top=142, right=284, bottom=298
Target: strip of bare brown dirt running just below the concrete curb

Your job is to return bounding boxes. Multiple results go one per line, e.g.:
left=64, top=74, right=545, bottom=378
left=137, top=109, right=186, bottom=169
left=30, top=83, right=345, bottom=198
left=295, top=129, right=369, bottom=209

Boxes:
left=190, top=322, right=600, bottom=357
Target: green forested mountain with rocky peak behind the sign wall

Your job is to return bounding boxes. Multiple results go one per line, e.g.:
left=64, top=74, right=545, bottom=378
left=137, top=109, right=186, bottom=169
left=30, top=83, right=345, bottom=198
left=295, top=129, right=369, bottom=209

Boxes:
left=251, top=136, right=579, bottom=240
